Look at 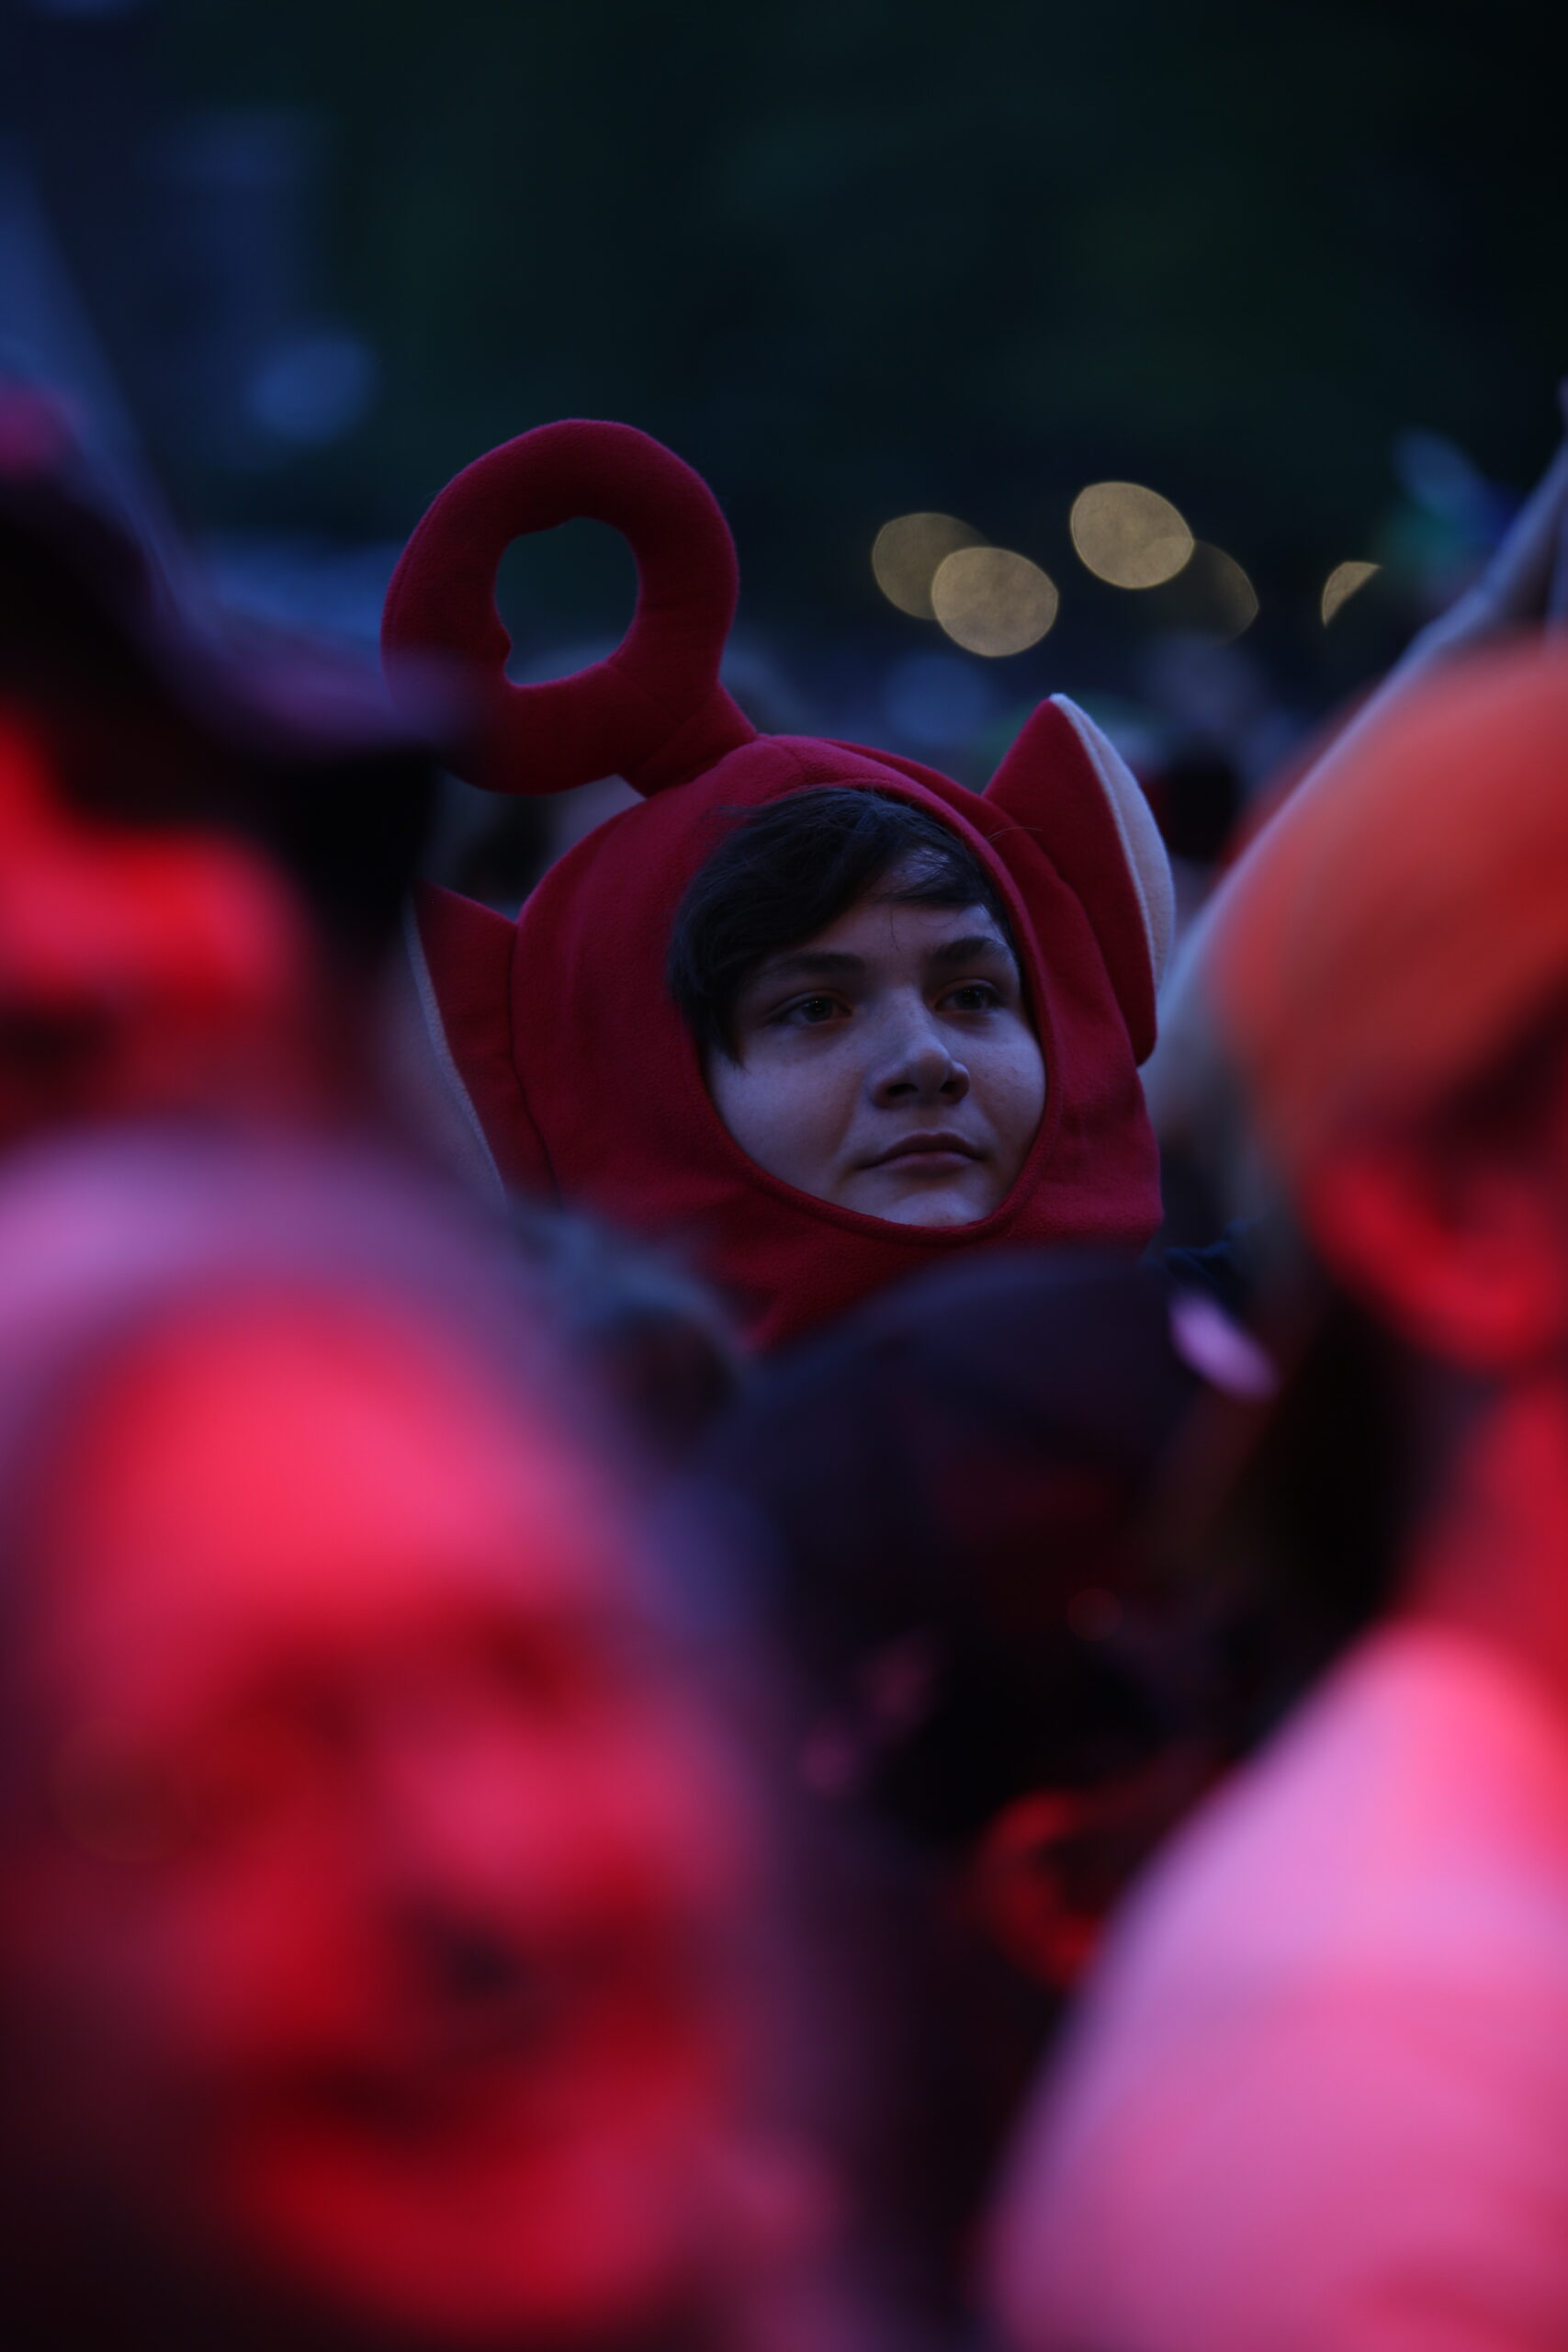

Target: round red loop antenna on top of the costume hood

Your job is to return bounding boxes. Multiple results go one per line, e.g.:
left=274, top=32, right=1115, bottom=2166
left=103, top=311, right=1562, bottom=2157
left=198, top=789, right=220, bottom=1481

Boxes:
left=381, top=433, right=755, bottom=793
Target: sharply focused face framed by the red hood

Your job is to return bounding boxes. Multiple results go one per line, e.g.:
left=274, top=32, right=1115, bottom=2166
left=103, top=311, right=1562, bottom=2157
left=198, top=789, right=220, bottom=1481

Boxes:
left=707, top=873, right=1046, bottom=1226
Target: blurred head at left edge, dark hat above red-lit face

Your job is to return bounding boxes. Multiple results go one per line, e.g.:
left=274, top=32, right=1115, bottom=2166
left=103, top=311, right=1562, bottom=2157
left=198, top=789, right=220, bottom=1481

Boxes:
left=0, top=388, right=430, bottom=1136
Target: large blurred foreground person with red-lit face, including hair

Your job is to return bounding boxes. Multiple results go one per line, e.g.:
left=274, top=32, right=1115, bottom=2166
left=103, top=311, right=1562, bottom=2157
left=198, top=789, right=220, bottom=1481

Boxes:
left=0, top=1141, right=841, bottom=2352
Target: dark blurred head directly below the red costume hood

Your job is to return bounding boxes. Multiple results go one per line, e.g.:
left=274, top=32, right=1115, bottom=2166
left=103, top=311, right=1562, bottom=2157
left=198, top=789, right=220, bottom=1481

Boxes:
left=710, top=1253, right=1218, bottom=1975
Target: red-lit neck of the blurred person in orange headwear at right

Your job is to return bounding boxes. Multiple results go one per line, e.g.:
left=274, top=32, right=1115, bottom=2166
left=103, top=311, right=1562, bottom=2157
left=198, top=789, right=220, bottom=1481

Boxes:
left=1404, top=1369, right=1568, bottom=1719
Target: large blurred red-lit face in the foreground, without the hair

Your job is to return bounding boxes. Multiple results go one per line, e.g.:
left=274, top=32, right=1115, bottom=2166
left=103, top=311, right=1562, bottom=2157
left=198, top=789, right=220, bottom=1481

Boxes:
left=0, top=1303, right=771, bottom=2345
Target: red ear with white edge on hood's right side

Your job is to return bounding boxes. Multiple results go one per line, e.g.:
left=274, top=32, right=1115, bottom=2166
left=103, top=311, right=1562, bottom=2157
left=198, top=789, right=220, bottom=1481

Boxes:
left=985, top=694, right=1176, bottom=1061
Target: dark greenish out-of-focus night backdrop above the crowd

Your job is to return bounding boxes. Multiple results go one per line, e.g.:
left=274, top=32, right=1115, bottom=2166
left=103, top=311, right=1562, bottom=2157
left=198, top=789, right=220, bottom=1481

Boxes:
left=12, top=0, right=1568, bottom=695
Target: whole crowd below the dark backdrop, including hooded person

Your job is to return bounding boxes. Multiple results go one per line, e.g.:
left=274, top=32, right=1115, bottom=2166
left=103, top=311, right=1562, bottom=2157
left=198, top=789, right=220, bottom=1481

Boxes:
left=0, top=367, right=1568, bottom=2352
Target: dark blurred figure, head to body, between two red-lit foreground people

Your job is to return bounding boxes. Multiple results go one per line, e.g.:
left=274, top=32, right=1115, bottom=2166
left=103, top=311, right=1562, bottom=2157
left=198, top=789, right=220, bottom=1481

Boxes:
left=701, top=1249, right=1267, bottom=2334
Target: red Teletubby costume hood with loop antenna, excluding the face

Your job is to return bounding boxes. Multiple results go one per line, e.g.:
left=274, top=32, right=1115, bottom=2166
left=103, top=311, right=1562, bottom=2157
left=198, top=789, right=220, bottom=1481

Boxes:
left=383, top=421, right=1170, bottom=1345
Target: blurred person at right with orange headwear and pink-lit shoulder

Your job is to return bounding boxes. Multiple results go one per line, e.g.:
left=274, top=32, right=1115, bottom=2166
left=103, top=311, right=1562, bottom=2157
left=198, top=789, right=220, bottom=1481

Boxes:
left=992, top=650, right=1568, bottom=2352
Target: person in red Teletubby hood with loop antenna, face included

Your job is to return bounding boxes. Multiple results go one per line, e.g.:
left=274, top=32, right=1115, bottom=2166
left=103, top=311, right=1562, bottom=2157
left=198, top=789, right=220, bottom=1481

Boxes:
left=383, top=421, right=1170, bottom=1345
